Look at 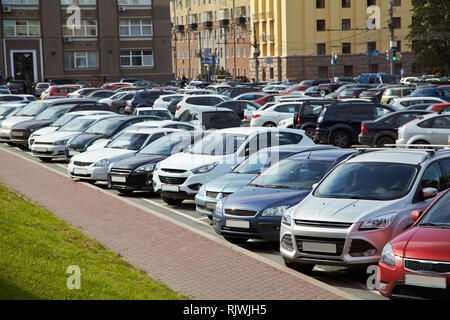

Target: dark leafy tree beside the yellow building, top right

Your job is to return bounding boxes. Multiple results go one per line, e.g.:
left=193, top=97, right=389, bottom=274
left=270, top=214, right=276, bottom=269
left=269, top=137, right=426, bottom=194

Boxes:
left=408, top=0, right=450, bottom=76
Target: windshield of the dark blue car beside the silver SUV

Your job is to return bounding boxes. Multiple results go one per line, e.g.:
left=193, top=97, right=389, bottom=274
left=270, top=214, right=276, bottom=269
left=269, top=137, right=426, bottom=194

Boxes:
left=250, top=159, right=332, bottom=189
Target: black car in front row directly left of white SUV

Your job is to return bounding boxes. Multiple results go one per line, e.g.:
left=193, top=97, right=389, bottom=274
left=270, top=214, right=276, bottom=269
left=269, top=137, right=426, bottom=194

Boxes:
left=108, top=131, right=205, bottom=194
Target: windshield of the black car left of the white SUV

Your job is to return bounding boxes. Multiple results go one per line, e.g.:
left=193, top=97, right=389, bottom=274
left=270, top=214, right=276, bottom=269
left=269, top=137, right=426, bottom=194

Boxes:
left=139, top=134, right=191, bottom=156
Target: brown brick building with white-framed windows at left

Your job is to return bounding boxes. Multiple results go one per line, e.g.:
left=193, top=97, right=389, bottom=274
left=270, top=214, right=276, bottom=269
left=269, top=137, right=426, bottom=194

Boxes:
left=0, top=0, right=174, bottom=84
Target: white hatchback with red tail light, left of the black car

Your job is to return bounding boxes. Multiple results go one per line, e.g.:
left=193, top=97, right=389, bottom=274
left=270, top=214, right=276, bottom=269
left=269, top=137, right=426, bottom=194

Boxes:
left=250, top=102, right=302, bottom=127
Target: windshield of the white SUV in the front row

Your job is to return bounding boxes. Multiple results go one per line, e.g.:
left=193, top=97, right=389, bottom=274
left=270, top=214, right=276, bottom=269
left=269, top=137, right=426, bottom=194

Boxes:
left=189, top=133, right=247, bottom=156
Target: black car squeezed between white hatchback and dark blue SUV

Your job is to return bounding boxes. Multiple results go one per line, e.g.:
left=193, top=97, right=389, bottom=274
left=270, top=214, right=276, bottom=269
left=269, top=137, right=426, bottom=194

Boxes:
left=294, top=100, right=336, bottom=140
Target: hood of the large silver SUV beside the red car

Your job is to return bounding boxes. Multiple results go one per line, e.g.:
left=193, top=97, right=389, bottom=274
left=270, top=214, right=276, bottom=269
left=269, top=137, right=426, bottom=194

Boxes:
left=293, top=195, right=398, bottom=223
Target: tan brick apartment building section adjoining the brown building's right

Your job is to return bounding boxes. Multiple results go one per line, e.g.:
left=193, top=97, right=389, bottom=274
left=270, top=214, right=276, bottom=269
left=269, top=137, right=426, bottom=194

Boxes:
left=170, top=0, right=253, bottom=79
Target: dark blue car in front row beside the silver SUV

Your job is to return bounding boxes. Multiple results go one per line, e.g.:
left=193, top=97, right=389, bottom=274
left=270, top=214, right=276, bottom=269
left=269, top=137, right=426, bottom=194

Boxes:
left=213, top=149, right=357, bottom=244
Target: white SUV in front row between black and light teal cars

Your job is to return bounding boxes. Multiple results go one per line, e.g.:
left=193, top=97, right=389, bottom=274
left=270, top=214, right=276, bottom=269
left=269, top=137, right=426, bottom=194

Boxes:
left=153, top=127, right=314, bottom=205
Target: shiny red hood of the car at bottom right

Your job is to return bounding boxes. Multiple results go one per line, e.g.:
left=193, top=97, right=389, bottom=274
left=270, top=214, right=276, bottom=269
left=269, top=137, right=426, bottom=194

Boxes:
left=392, top=227, right=450, bottom=262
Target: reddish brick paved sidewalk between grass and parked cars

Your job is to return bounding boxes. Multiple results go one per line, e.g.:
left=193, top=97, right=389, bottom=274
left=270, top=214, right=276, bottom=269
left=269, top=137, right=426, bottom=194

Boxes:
left=0, top=150, right=354, bottom=300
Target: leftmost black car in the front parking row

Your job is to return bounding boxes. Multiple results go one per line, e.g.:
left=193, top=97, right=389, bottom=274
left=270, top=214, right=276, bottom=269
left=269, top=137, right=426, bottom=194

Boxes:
left=11, top=102, right=110, bottom=147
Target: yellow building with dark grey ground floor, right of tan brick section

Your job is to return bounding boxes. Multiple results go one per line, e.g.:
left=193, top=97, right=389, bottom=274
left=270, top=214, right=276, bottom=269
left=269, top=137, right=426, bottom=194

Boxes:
left=250, top=0, right=418, bottom=80
